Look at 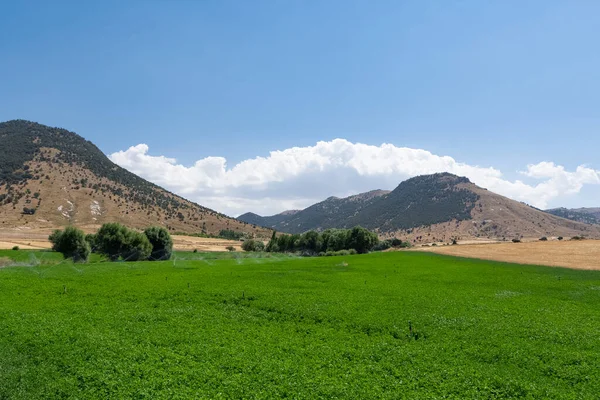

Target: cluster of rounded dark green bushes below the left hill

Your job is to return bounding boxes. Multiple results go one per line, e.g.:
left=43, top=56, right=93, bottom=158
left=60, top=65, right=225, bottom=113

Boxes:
left=49, top=223, right=173, bottom=262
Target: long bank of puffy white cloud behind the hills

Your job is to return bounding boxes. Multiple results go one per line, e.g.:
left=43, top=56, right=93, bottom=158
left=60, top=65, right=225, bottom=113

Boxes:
left=110, top=139, right=600, bottom=215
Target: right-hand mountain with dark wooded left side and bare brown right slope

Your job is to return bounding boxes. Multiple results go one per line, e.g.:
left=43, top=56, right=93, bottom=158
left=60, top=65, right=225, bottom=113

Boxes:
left=239, top=173, right=600, bottom=243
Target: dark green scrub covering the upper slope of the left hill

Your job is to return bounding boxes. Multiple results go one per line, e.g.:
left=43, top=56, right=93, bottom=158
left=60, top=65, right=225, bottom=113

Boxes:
left=0, top=120, right=268, bottom=234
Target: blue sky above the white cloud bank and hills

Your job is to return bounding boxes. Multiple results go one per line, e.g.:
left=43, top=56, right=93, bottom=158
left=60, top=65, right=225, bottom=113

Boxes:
left=0, top=0, right=600, bottom=213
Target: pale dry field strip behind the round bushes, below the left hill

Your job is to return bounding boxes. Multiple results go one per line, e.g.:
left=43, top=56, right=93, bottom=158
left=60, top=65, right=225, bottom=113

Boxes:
left=0, top=229, right=242, bottom=251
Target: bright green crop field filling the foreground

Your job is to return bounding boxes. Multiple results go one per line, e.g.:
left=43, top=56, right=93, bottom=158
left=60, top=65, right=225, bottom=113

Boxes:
left=0, top=250, right=600, bottom=399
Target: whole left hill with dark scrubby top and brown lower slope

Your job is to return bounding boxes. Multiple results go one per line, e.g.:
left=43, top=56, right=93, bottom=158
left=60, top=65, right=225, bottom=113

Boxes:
left=0, top=120, right=270, bottom=237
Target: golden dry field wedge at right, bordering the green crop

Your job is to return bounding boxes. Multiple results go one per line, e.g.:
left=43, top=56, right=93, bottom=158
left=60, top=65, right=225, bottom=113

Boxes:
left=415, top=240, right=600, bottom=270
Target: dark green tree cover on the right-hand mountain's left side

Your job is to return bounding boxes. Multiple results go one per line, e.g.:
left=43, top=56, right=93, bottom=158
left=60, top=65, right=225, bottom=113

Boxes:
left=239, top=173, right=479, bottom=233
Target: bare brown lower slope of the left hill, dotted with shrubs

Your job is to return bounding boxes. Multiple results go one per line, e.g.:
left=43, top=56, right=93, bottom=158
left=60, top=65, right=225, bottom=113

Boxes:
left=0, top=148, right=272, bottom=238
